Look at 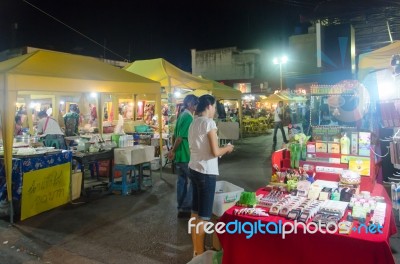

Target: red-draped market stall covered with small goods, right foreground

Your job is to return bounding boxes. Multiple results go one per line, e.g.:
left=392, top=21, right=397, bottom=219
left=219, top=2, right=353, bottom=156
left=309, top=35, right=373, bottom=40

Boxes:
left=219, top=81, right=397, bottom=263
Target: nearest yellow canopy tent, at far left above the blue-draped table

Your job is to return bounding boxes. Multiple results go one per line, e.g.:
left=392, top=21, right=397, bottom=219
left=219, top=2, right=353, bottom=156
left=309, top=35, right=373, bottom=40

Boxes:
left=0, top=50, right=162, bottom=222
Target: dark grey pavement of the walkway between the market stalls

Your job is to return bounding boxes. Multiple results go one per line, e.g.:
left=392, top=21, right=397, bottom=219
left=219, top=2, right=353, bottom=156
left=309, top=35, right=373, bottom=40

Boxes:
left=0, top=133, right=400, bottom=264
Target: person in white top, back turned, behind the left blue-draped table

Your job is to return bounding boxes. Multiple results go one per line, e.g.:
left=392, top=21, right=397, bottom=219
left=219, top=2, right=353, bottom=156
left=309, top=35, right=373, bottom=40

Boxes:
left=37, top=111, right=66, bottom=149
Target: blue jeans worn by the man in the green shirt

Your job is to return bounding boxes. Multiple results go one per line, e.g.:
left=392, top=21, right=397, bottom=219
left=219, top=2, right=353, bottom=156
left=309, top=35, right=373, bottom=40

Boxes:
left=175, top=162, right=193, bottom=212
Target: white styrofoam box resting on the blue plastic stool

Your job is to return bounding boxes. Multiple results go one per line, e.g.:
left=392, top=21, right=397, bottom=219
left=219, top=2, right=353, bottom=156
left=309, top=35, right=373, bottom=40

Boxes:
left=114, top=145, right=154, bottom=165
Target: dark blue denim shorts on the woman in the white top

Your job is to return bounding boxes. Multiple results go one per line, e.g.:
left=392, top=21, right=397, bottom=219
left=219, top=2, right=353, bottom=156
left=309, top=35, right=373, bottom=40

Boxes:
left=190, top=169, right=217, bottom=221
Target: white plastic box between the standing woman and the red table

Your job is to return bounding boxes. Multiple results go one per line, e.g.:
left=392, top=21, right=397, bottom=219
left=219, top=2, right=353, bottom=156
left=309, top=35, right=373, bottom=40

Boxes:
left=213, top=181, right=244, bottom=217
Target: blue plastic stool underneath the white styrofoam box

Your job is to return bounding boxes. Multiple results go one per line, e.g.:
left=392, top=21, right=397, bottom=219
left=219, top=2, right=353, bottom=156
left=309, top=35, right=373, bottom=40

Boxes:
left=110, top=164, right=140, bottom=195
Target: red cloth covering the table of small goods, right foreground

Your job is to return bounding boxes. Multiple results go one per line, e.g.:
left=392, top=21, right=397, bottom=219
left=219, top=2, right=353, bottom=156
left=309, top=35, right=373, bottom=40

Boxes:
left=218, top=185, right=397, bottom=264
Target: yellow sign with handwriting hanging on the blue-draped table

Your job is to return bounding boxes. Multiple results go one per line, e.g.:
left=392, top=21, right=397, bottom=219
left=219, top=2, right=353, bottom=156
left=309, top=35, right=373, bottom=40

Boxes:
left=21, top=162, right=71, bottom=220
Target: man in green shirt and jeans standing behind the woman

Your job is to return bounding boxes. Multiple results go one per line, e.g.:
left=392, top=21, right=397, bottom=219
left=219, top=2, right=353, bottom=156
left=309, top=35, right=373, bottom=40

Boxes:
left=168, top=94, right=198, bottom=218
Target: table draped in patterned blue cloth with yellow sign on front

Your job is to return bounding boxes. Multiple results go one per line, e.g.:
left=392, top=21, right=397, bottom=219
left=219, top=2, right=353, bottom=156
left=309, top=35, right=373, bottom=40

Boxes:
left=0, top=151, right=72, bottom=220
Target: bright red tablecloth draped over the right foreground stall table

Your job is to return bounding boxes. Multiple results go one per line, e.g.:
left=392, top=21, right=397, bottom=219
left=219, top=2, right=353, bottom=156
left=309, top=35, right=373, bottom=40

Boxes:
left=218, top=184, right=397, bottom=264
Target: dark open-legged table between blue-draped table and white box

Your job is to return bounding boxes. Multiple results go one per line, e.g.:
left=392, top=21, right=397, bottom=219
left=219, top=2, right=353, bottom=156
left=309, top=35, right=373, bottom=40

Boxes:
left=72, top=149, right=114, bottom=195
